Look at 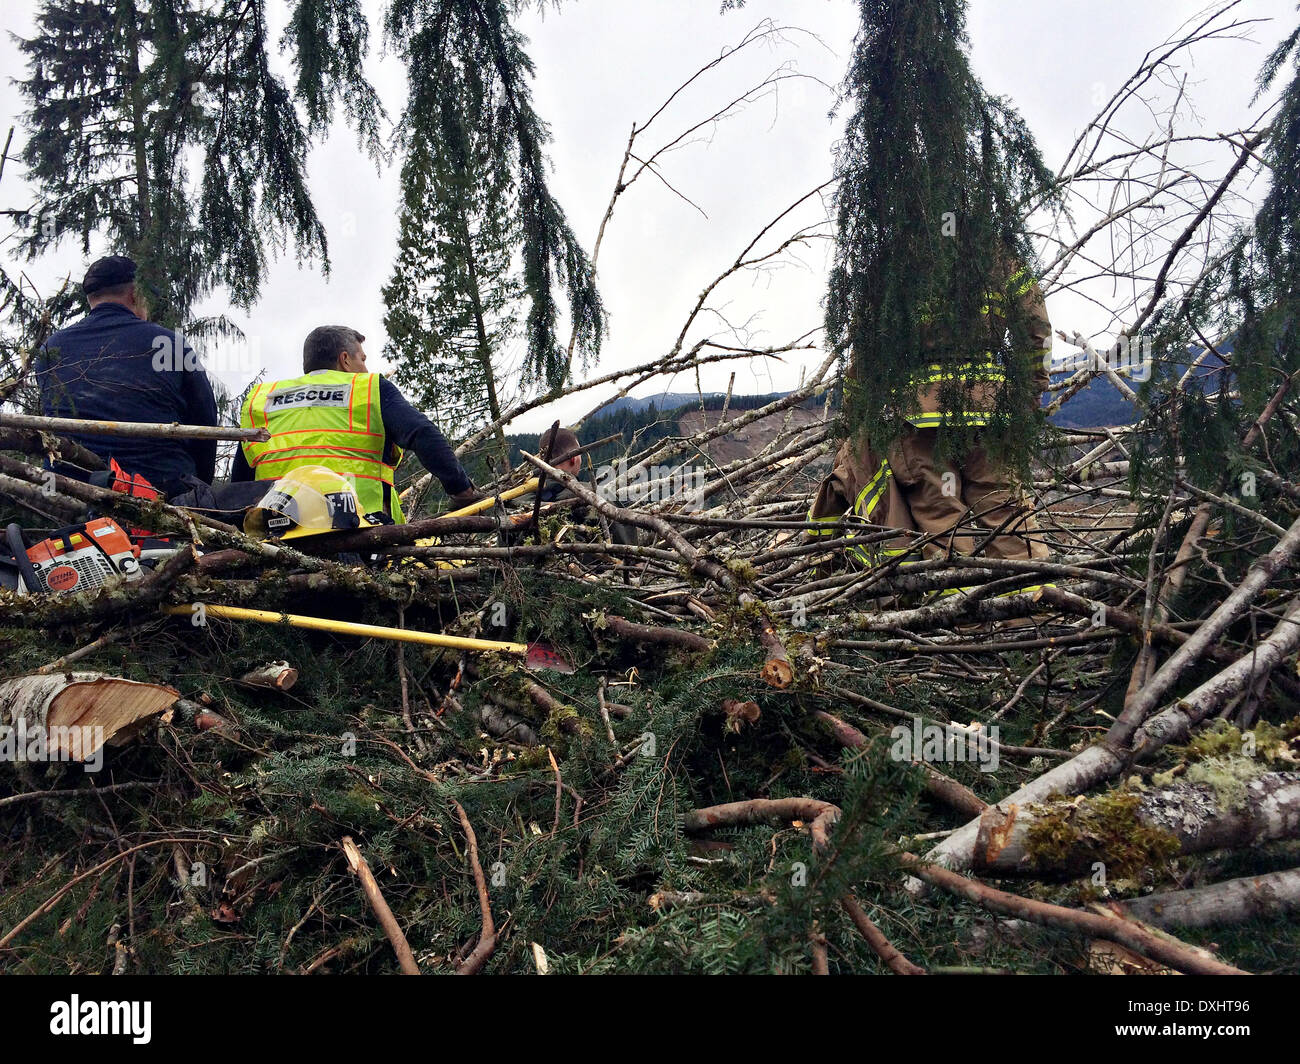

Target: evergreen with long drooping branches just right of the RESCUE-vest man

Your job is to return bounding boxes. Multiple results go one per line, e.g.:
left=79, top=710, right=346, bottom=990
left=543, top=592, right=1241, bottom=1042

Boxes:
left=385, top=0, right=605, bottom=446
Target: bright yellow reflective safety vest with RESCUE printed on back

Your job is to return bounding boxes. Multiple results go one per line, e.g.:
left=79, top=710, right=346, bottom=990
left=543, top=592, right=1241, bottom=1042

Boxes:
left=239, top=369, right=406, bottom=524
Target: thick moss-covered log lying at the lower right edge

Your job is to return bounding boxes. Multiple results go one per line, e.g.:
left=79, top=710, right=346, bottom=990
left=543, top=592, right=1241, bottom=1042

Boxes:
left=975, top=773, right=1300, bottom=878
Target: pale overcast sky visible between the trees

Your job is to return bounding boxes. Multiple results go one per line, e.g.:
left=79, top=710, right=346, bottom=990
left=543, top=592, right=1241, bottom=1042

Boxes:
left=0, top=0, right=1297, bottom=431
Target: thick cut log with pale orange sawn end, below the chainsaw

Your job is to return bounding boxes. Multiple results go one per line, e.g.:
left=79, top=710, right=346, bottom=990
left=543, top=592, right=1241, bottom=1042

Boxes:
left=0, top=672, right=181, bottom=761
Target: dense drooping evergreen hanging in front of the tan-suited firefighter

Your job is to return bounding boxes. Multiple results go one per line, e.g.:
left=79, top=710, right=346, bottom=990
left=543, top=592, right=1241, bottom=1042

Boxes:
left=827, top=0, right=1050, bottom=468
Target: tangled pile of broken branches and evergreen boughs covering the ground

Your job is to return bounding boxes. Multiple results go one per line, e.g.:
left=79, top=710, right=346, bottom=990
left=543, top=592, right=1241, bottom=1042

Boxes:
left=0, top=362, right=1300, bottom=973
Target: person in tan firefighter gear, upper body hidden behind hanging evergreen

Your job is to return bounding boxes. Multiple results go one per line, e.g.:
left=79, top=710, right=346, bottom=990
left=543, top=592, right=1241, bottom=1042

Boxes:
left=809, top=260, right=1052, bottom=565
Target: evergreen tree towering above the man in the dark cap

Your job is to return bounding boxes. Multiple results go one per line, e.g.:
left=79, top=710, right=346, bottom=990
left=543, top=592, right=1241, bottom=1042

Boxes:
left=18, top=0, right=382, bottom=323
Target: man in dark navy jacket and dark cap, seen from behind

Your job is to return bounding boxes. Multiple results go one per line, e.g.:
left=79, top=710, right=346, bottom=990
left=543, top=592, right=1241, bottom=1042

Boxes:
left=36, top=255, right=217, bottom=496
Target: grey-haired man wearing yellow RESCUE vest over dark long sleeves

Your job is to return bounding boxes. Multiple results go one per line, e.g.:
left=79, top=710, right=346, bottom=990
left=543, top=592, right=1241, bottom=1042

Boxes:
left=230, top=325, right=482, bottom=524
